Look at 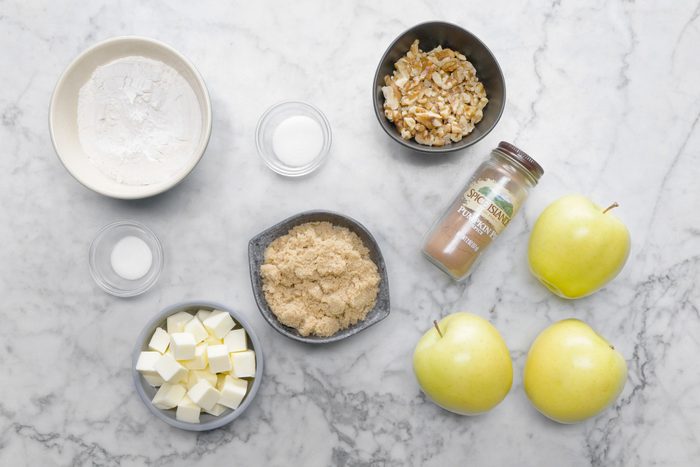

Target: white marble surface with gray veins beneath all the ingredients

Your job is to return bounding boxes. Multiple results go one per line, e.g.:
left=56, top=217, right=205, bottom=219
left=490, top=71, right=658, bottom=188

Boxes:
left=0, top=0, right=700, bottom=466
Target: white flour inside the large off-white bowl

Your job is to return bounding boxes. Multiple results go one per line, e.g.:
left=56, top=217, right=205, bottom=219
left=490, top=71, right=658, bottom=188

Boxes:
left=78, top=56, right=202, bottom=185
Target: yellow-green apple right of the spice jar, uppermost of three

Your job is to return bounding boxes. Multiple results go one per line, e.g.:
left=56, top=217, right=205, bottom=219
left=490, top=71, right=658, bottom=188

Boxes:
left=528, top=195, right=630, bottom=298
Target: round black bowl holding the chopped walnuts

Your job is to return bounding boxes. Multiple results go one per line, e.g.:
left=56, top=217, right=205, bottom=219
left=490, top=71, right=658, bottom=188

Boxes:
left=372, top=21, right=506, bottom=154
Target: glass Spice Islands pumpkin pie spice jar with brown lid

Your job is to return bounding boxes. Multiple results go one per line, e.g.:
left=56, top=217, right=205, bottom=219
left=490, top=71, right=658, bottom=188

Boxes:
left=423, top=141, right=544, bottom=280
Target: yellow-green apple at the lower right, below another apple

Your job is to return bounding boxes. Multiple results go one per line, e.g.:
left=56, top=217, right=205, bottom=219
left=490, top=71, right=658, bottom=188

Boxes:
left=523, top=319, right=627, bottom=423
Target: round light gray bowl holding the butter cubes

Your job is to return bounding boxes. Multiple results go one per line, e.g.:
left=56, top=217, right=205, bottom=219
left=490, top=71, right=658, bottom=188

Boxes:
left=131, top=300, right=263, bottom=431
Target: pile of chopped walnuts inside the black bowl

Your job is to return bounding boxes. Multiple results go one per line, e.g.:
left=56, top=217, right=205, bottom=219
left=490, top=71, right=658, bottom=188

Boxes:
left=382, top=39, right=489, bottom=146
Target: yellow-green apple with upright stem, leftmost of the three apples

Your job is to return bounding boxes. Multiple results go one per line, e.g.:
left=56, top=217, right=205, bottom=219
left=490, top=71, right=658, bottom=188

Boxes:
left=413, top=312, right=513, bottom=415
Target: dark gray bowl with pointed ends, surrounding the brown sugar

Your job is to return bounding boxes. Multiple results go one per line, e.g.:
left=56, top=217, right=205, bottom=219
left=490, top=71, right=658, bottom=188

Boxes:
left=248, top=211, right=390, bottom=344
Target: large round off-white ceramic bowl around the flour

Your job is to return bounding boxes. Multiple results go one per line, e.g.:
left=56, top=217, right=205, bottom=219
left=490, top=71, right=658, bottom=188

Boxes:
left=49, top=36, right=212, bottom=199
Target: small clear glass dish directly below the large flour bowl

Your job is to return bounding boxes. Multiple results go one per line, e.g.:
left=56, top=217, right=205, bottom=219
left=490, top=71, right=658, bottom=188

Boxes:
left=89, top=221, right=163, bottom=297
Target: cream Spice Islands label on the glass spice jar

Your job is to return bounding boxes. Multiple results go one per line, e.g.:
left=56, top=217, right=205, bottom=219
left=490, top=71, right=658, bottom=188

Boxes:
left=460, top=178, right=514, bottom=238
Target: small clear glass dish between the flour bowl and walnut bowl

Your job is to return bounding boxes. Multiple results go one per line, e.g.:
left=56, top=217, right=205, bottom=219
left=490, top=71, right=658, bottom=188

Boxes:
left=255, top=101, right=332, bottom=177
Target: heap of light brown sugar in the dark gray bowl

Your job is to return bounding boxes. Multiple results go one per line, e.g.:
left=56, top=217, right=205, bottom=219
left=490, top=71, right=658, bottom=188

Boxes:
left=260, top=222, right=379, bottom=337
